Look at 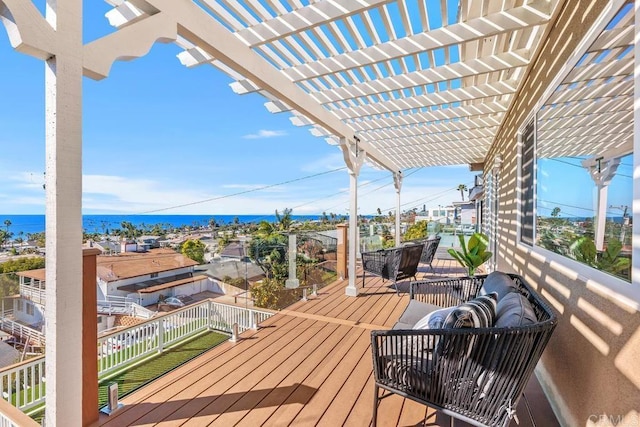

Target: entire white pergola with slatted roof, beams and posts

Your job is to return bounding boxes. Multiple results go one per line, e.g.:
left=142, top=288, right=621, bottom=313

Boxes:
left=0, top=0, right=584, bottom=425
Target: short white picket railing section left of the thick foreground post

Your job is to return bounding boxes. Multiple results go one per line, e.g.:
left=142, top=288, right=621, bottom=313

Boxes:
left=0, top=356, right=45, bottom=412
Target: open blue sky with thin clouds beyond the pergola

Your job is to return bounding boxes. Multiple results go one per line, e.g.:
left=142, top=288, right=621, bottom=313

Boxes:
left=0, top=1, right=473, bottom=215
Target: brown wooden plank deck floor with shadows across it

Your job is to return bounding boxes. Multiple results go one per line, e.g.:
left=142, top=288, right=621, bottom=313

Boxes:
left=100, top=260, right=558, bottom=427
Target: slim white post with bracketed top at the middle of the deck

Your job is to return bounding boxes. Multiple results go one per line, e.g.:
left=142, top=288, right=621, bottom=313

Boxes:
left=340, top=138, right=366, bottom=297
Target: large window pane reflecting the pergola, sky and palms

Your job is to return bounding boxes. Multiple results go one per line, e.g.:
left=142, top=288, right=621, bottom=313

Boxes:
left=520, top=4, right=634, bottom=282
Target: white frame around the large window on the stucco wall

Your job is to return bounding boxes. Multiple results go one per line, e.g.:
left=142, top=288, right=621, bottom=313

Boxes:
left=516, top=1, right=640, bottom=311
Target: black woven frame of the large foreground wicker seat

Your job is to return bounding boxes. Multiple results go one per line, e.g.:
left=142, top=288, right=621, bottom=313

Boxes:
left=371, top=274, right=557, bottom=427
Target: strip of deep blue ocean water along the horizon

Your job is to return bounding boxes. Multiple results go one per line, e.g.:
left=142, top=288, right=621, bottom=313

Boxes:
left=0, top=214, right=320, bottom=238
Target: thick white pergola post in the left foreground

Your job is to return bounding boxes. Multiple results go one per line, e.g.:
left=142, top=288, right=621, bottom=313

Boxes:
left=45, top=0, right=84, bottom=426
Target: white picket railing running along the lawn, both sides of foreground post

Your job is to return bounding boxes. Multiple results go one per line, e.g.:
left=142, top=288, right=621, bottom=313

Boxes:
left=0, top=300, right=274, bottom=411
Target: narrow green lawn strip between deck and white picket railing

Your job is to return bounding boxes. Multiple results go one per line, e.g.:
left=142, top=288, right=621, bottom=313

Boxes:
left=31, top=332, right=229, bottom=422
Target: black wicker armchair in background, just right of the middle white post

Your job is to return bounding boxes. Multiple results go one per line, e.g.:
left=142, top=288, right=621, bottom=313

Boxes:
left=362, top=243, right=424, bottom=294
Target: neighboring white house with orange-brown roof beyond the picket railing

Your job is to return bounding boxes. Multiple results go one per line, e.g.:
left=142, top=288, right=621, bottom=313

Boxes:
left=97, top=249, right=214, bottom=306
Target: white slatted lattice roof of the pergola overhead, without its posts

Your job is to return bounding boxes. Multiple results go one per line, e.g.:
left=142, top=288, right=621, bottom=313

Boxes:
left=100, top=0, right=557, bottom=172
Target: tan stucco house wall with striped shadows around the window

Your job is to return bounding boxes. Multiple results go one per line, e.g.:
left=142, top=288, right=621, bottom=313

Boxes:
left=485, top=0, right=640, bottom=426
